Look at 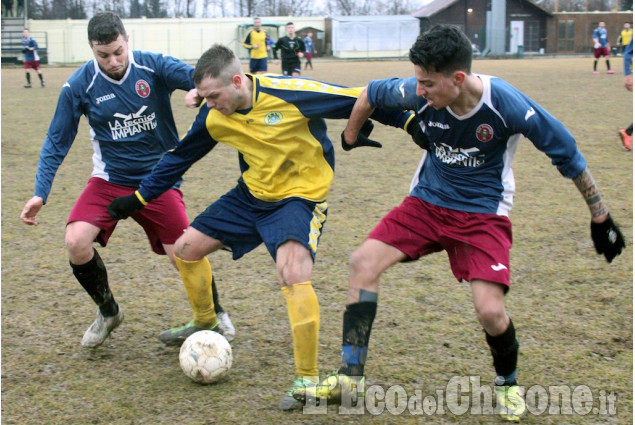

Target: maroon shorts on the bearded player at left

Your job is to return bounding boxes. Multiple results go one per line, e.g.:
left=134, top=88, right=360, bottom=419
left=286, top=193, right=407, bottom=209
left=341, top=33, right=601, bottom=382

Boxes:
left=66, top=177, right=189, bottom=255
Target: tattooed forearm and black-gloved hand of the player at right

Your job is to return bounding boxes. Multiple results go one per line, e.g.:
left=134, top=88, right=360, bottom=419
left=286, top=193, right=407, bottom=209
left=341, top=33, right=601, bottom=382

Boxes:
left=573, top=168, right=626, bottom=263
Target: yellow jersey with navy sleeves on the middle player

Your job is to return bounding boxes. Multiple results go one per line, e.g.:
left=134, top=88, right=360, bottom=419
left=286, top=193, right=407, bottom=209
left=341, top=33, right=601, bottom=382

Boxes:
left=139, top=74, right=413, bottom=202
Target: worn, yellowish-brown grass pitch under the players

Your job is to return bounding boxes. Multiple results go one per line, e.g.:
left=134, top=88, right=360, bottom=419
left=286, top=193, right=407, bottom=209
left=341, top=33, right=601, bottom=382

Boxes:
left=1, top=58, right=633, bottom=425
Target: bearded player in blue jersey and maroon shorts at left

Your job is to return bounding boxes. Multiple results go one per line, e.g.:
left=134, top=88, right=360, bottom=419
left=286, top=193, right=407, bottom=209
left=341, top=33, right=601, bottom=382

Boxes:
left=20, top=12, right=234, bottom=347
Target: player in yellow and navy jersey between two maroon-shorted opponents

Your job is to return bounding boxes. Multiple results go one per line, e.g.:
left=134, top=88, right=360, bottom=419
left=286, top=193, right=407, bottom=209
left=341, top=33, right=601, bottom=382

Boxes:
left=109, top=45, right=420, bottom=410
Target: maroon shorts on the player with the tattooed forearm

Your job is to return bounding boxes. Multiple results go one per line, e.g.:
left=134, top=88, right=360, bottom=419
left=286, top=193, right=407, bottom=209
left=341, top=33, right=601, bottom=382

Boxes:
left=368, top=196, right=512, bottom=290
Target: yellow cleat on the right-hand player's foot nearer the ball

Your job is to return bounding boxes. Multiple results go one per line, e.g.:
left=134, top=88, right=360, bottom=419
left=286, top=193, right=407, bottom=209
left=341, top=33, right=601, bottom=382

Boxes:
left=293, top=373, right=365, bottom=405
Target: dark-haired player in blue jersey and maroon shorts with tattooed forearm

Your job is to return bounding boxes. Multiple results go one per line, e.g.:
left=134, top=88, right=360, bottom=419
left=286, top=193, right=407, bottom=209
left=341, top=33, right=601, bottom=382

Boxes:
left=294, top=25, right=624, bottom=420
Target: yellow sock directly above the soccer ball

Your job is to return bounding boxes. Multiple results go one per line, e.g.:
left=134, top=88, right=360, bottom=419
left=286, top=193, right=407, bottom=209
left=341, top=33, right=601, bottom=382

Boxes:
left=174, top=255, right=216, bottom=328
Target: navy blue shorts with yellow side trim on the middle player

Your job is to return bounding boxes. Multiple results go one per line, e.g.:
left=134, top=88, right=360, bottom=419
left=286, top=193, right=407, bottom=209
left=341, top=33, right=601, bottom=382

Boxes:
left=190, top=184, right=328, bottom=261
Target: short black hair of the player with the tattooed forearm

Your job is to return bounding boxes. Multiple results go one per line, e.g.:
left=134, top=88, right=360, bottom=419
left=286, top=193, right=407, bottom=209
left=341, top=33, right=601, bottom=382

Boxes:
left=409, top=25, right=472, bottom=75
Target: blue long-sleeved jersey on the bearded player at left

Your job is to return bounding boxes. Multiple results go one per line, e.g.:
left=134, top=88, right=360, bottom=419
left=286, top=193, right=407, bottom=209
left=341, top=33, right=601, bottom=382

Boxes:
left=35, top=51, right=194, bottom=202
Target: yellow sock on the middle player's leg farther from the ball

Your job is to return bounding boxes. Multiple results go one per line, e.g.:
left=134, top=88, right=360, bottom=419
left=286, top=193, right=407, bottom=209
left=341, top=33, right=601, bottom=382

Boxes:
left=282, top=281, right=320, bottom=382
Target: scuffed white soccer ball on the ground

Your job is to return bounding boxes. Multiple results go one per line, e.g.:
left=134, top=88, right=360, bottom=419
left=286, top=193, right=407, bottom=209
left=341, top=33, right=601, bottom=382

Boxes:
left=179, top=331, right=233, bottom=384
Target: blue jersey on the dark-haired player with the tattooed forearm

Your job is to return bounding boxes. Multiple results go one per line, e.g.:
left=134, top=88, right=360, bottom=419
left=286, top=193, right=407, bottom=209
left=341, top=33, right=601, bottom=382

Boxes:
left=368, top=75, right=586, bottom=215
